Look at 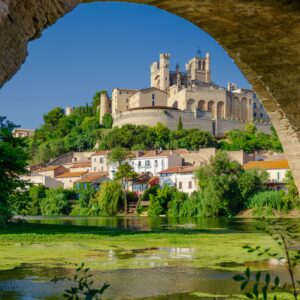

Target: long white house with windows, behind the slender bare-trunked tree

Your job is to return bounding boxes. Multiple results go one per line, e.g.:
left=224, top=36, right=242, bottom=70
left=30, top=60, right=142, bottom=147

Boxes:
left=109, top=150, right=182, bottom=178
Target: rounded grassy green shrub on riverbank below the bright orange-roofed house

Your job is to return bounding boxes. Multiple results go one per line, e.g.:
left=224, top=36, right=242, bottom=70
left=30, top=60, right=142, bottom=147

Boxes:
left=248, top=191, right=291, bottom=217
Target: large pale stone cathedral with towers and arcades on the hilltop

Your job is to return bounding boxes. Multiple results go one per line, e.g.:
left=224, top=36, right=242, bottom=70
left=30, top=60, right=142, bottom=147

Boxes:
left=100, top=53, right=270, bottom=136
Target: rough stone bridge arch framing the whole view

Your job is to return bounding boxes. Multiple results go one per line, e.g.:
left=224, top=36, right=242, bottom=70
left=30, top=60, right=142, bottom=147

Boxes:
left=0, top=0, right=300, bottom=188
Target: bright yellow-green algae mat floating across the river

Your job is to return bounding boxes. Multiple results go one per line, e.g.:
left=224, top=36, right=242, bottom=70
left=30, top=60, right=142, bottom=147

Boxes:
left=0, top=223, right=277, bottom=270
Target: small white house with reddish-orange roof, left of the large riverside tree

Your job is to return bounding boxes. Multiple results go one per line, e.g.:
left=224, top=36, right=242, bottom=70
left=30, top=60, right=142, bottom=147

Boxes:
left=159, top=166, right=197, bottom=194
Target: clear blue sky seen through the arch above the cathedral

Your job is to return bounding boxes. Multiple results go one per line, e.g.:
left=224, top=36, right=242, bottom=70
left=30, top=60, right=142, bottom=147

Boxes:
left=0, top=3, right=251, bottom=128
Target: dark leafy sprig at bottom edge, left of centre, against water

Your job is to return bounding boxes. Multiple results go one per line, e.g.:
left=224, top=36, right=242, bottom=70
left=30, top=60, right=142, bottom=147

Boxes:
left=52, top=263, right=109, bottom=300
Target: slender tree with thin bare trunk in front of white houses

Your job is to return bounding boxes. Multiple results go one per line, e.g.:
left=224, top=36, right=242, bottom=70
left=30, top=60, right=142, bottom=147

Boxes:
left=108, top=147, right=137, bottom=214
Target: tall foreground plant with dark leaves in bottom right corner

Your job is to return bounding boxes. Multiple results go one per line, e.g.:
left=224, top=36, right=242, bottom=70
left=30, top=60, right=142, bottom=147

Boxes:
left=233, top=220, right=300, bottom=300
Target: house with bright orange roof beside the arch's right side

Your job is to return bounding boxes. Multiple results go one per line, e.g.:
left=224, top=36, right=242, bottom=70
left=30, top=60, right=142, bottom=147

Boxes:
left=244, top=159, right=289, bottom=190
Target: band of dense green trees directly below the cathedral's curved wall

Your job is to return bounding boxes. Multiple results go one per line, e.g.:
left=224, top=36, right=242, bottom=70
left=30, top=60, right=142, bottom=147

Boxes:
left=99, top=123, right=217, bottom=150
